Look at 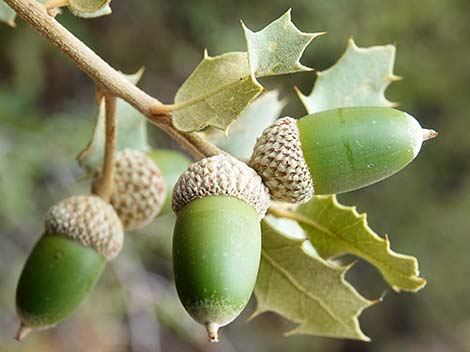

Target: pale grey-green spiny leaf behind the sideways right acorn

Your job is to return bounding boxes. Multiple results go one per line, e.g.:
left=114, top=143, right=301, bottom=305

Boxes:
left=297, top=38, right=401, bottom=114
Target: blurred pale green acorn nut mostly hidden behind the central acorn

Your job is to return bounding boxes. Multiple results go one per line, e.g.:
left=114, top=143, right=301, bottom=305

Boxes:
left=148, top=149, right=191, bottom=214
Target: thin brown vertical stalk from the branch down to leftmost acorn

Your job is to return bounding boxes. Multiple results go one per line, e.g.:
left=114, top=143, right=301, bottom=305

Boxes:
left=93, top=93, right=117, bottom=202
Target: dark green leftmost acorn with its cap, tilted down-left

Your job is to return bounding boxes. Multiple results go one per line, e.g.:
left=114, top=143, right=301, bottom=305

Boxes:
left=16, top=195, right=124, bottom=341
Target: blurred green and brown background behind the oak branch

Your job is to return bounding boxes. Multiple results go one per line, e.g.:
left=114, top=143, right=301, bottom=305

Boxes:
left=0, top=0, right=470, bottom=352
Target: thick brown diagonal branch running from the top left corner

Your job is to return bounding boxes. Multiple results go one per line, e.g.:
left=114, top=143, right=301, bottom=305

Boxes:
left=4, top=0, right=223, bottom=159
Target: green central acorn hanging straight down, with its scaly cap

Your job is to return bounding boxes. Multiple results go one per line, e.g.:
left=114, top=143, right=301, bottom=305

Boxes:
left=172, top=154, right=270, bottom=342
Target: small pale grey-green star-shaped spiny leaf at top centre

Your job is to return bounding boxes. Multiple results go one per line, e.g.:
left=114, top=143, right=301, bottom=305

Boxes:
left=242, top=9, right=323, bottom=77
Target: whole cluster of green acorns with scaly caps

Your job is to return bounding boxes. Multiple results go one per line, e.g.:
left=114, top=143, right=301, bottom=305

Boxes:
left=17, top=107, right=436, bottom=341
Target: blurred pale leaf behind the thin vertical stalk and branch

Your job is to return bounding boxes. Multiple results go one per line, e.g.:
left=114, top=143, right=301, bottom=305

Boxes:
left=77, top=68, right=149, bottom=170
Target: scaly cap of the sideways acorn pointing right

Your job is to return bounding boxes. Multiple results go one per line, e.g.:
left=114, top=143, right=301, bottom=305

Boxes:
left=249, top=117, right=314, bottom=203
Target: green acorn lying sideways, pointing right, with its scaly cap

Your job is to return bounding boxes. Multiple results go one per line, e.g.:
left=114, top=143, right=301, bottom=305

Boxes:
left=249, top=107, right=437, bottom=203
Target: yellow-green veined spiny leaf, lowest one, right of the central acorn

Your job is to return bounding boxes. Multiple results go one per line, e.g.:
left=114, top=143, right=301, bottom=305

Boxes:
left=253, top=221, right=374, bottom=341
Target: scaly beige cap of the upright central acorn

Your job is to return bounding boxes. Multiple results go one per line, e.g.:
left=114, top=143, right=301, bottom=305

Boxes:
left=172, top=154, right=270, bottom=219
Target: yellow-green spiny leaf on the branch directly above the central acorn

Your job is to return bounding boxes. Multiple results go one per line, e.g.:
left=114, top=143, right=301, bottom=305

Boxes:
left=173, top=52, right=263, bottom=132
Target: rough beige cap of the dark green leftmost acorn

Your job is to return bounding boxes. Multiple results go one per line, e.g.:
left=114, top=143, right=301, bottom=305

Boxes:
left=45, top=195, right=124, bottom=260
